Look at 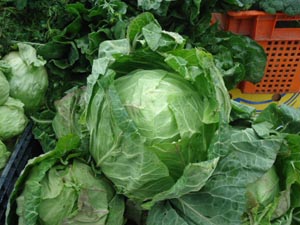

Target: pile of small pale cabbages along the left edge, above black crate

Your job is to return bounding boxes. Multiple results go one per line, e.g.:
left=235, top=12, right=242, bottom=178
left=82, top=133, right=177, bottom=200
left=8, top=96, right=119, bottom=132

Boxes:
left=0, top=43, right=48, bottom=170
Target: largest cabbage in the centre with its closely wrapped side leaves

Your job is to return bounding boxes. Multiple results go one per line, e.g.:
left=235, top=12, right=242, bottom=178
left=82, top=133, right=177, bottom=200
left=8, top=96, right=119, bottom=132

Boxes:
left=87, top=50, right=229, bottom=208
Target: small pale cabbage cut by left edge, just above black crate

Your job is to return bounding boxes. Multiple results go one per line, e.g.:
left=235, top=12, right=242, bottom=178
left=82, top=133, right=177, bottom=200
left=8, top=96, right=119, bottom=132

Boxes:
left=0, top=97, right=28, bottom=141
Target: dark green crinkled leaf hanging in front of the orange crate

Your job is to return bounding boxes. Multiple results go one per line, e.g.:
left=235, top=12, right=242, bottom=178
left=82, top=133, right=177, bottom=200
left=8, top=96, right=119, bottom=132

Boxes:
left=199, top=26, right=267, bottom=90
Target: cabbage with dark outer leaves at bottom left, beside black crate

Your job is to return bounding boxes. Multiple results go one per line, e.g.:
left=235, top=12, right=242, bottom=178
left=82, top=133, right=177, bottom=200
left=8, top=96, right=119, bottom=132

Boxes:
left=7, top=135, right=124, bottom=225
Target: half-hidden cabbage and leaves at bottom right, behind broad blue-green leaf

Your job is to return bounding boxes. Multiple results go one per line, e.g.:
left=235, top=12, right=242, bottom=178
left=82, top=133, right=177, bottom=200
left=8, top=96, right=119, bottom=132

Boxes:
left=237, top=104, right=300, bottom=225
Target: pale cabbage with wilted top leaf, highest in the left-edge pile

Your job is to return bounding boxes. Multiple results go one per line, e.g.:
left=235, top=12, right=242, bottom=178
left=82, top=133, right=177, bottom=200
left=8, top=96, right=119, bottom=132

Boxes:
left=2, top=43, right=48, bottom=113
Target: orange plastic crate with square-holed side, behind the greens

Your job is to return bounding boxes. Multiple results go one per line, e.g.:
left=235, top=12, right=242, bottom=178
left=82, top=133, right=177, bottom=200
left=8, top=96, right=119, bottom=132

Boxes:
left=213, top=10, right=300, bottom=93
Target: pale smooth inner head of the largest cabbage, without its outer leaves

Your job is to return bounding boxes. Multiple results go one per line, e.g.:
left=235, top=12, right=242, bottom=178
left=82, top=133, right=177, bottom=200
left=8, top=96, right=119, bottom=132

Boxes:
left=115, top=70, right=215, bottom=179
